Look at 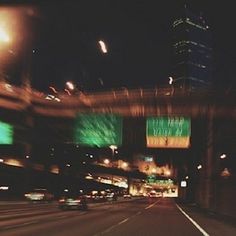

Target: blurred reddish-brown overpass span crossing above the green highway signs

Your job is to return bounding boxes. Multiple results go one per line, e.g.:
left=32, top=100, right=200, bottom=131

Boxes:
left=0, top=84, right=236, bottom=119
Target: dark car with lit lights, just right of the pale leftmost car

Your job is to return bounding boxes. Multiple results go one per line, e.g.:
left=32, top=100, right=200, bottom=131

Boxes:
left=58, top=195, right=88, bottom=210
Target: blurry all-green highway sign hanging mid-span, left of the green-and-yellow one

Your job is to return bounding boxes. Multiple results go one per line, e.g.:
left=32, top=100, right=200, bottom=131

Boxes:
left=74, top=114, right=123, bottom=147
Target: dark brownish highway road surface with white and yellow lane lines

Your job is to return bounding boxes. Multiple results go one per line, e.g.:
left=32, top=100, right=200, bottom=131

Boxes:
left=0, top=198, right=236, bottom=236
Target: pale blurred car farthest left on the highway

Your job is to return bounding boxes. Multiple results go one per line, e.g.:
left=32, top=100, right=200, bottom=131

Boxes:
left=24, top=188, right=54, bottom=202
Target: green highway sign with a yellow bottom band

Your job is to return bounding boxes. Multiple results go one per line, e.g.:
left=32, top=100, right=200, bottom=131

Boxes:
left=146, top=117, right=191, bottom=148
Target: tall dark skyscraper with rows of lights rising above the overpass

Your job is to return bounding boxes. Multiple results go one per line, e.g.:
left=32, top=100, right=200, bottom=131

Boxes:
left=172, top=6, right=212, bottom=90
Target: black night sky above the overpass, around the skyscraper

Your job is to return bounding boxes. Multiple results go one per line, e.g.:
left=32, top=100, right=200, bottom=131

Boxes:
left=3, top=0, right=236, bottom=91
